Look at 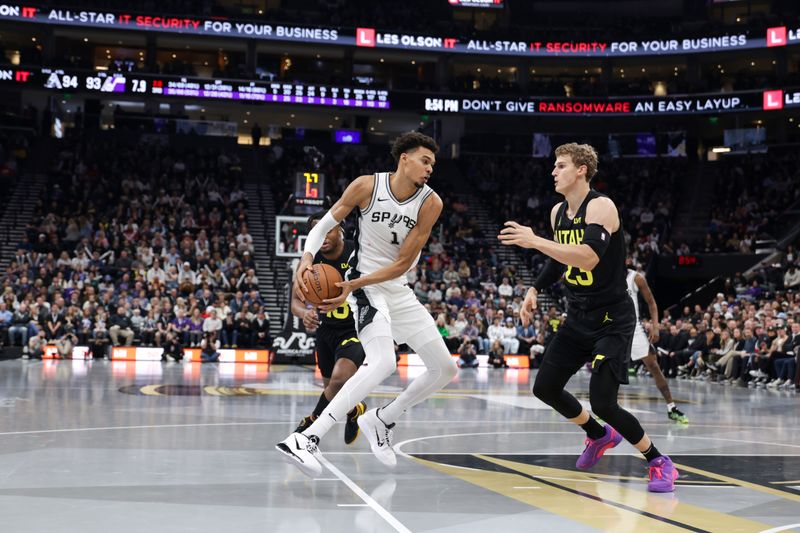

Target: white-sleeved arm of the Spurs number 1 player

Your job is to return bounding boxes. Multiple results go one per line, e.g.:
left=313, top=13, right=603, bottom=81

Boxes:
left=294, top=176, right=375, bottom=302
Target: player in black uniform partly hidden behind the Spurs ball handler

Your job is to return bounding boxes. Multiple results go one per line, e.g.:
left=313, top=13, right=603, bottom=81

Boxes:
left=292, top=212, right=367, bottom=444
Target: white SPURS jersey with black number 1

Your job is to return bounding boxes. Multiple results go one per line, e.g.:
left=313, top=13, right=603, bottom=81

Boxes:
left=347, top=172, right=433, bottom=285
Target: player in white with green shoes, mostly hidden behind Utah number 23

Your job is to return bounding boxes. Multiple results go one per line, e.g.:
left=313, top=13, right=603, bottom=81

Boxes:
left=627, top=262, right=689, bottom=424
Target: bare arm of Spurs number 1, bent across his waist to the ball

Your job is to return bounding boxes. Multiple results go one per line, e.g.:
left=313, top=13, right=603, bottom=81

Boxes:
left=319, top=193, right=442, bottom=312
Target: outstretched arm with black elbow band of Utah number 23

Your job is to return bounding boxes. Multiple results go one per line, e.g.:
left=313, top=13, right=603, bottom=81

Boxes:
left=498, top=197, right=619, bottom=271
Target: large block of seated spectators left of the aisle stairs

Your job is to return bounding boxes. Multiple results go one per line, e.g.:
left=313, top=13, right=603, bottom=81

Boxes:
left=0, top=136, right=270, bottom=356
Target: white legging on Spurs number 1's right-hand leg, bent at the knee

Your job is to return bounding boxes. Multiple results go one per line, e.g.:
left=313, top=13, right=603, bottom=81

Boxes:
left=378, top=337, right=458, bottom=425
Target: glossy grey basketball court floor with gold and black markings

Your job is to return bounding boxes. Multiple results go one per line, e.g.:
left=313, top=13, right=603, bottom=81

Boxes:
left=0, top=360, right=800, bottom=533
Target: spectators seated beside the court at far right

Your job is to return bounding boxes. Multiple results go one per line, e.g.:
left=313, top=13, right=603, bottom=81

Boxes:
left=649, top=251, right=800, bottom=391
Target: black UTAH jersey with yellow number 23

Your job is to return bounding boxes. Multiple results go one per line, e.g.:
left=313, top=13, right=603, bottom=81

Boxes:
left=554, top=190, right=629, bottom=311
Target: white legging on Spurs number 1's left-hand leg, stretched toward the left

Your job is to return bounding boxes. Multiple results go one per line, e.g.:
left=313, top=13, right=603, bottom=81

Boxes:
left=303, top=330, right=397, bottom=438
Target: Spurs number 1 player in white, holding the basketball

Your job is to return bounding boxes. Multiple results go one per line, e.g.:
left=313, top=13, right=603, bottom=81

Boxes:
left=276, top=132, right=458, bottom=476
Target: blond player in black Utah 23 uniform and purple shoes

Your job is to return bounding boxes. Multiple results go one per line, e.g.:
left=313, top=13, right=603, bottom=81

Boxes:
left=498, top=143, right=678, bottom=492
